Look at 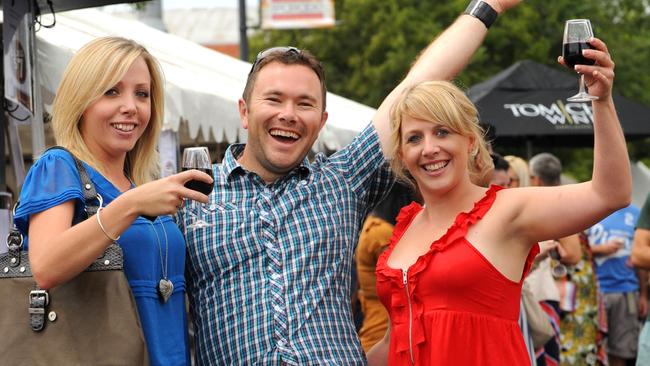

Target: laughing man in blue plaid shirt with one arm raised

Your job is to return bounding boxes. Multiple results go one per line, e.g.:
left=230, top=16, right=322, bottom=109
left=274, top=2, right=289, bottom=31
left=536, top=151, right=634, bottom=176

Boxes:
left=179, top=0, right=520, bottom=365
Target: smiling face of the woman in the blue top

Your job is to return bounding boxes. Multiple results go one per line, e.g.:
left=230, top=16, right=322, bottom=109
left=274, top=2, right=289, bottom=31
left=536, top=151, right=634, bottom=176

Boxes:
left=79, top=57, right=151, bottom=161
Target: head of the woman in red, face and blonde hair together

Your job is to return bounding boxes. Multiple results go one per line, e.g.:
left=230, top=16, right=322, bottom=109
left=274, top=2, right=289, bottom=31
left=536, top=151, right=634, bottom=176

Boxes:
left=390, top=81, right=494, bottom=190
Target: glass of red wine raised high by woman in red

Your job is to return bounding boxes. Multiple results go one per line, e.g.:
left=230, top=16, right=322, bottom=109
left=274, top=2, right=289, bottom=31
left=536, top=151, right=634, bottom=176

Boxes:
left=562, top=19, right=598, bottom=102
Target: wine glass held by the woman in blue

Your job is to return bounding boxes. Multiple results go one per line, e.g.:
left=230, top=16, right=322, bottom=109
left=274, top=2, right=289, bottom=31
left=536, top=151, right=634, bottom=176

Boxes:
left=181, top=146, right=214, bottom=229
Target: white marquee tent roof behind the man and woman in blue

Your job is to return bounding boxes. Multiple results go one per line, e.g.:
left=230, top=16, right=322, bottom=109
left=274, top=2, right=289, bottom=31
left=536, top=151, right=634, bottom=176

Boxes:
left=36, top=9, right=375, bottom=151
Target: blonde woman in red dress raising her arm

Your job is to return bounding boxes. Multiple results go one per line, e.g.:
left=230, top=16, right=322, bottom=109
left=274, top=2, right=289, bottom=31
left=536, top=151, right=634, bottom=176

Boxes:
left=368, top=39, right=631, bottom=366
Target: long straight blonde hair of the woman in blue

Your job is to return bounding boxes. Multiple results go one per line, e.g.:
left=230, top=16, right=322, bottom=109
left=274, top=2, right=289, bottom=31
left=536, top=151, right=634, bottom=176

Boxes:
left=52, top=37, right=164, bottom=185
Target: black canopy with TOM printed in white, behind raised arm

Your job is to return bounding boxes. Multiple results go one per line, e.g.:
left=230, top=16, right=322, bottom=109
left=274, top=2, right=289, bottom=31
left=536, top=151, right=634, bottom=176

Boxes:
left=468, top=60, right=650, bottom=146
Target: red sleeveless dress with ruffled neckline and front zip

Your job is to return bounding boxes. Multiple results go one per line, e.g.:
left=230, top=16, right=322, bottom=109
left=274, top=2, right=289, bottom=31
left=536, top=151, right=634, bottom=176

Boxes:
left=376, top=186, right=539, bottom=366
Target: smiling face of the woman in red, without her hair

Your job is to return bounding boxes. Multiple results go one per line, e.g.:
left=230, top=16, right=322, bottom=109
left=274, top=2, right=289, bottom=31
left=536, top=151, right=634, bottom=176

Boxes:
left=399, top=116, right=472, bottom=193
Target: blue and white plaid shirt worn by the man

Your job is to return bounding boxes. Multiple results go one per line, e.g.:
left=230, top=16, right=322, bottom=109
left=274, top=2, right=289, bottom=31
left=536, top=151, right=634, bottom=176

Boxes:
left=178, top=124, right=393, bottom=365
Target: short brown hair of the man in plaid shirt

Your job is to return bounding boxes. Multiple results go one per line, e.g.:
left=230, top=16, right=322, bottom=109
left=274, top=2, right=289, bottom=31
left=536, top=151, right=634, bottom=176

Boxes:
left=242, top=46, right=327, bottom=111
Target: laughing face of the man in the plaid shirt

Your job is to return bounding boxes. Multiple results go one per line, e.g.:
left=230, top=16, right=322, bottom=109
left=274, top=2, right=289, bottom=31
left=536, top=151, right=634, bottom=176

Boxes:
left=239, top=62, right=327, bottom=182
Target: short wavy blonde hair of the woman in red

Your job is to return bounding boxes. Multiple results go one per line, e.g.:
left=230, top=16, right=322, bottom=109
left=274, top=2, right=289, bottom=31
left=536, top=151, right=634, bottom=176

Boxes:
left=390, top=81, right=494, bottom=185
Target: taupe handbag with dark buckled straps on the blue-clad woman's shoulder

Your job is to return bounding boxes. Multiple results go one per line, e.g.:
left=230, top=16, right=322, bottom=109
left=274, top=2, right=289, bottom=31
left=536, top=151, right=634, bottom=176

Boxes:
left=0, top=147, right=149, bottom=365
